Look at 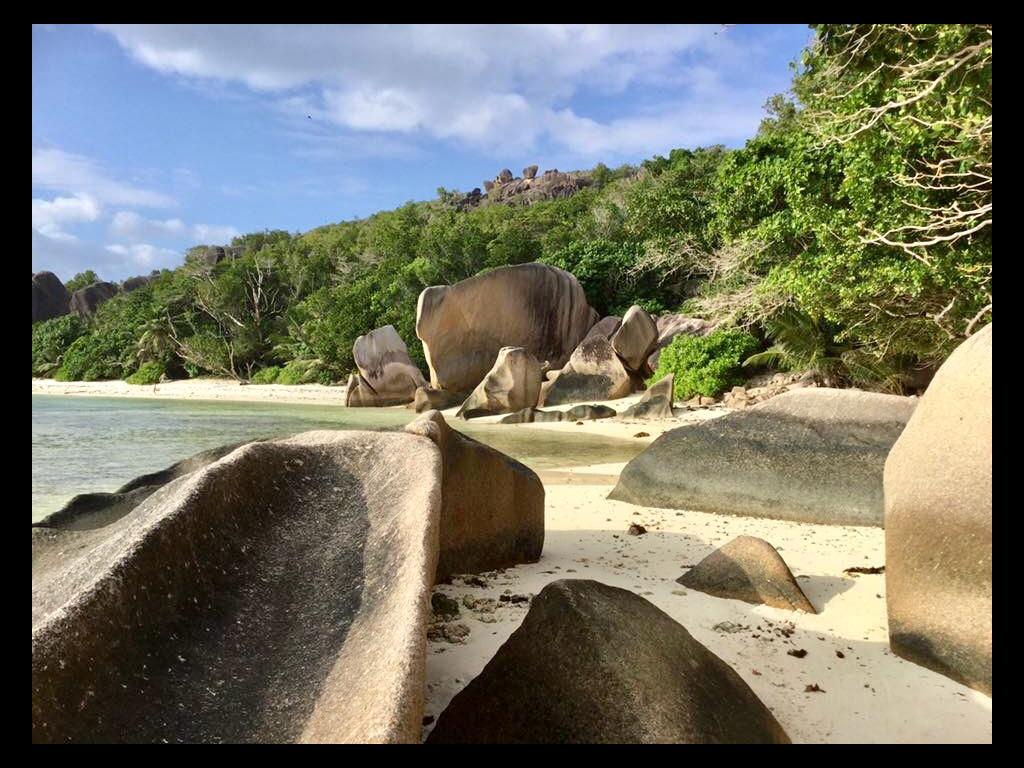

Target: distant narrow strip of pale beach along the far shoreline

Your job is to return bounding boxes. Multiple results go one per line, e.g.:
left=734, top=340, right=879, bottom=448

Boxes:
left=32, top=379, right=345, bottom=407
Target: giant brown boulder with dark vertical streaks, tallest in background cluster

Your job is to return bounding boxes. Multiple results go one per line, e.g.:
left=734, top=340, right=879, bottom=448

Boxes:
left=416, top=263, right=598, bottom=395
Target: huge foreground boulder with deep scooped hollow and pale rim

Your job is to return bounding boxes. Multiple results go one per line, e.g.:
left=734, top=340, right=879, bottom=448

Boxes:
left=32, top=432, right=441, bottom=742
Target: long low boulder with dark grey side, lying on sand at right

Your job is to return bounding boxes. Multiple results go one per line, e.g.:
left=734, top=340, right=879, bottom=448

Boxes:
left=608, top=388, right=916, bottom=526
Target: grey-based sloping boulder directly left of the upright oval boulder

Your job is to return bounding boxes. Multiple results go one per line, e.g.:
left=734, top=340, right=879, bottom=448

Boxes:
left=541, top=335, right=637, bottom=406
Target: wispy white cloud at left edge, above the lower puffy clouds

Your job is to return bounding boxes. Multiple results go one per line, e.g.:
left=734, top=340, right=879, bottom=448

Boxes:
left=32, top=146, right=177, bottom=208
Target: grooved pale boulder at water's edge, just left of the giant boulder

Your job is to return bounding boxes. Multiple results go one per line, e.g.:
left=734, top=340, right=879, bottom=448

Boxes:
left=345, top=326, right=427, bottom=408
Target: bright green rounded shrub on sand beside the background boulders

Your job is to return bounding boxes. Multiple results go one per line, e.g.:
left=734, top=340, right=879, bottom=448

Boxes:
left=648, top=329, right=758, bottom=399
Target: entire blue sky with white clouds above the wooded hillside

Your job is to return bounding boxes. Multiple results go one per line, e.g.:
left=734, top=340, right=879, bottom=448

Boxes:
left=32, top=25, right=811, bottom=280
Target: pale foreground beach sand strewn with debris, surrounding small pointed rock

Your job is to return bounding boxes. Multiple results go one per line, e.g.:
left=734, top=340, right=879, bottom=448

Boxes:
left=424, top=473, right=992, bottom=743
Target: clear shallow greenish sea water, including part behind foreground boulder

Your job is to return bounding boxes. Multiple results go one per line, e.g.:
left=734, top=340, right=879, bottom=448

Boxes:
left=32, top=394, right=642, bottom=521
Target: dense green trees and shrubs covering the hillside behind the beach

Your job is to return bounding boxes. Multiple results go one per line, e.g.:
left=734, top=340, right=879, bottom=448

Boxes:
left=33, top=25, right=992, bottom=393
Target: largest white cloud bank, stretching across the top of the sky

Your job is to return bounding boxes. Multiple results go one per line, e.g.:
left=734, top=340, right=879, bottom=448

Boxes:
left=101, top=25, right=796, bottom=158
